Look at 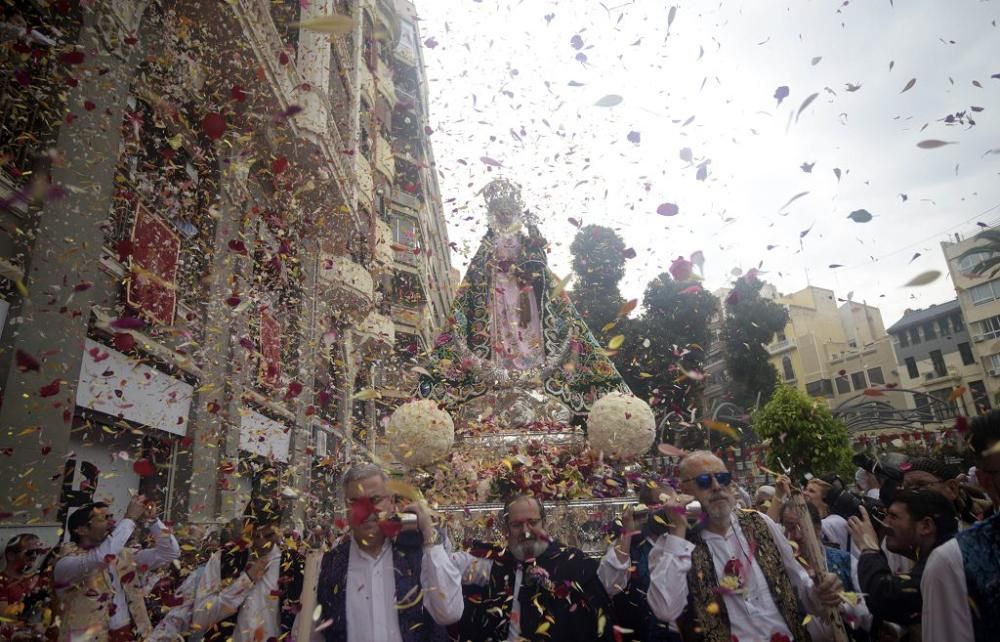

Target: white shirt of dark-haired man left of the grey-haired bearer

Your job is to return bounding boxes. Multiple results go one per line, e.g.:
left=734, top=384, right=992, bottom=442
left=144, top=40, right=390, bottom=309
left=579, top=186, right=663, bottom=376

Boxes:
left=191, top=546, right=281, bottom=642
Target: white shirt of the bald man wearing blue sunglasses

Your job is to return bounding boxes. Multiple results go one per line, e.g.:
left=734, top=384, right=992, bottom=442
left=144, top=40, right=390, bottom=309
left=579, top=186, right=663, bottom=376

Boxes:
left=647, top=514, right=820, bottom=640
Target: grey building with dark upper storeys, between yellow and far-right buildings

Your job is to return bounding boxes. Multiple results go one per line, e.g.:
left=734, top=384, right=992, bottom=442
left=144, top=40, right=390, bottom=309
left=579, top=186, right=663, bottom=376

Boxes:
left=888, top=299, right=980, bottom=422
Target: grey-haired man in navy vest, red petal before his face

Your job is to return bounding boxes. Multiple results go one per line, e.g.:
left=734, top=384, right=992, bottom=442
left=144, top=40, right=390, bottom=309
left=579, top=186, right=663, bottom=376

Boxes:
left=297, top=464, right=462, bottom=642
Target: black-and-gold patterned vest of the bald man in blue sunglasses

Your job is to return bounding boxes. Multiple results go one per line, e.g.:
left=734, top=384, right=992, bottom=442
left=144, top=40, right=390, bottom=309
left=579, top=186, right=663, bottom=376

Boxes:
left=678, top=511, right=810, bottom=642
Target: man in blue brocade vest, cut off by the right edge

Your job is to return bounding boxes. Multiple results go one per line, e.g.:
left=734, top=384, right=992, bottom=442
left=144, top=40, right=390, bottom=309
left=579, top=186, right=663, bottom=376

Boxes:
left=920, top=410, right=1000, bottom=642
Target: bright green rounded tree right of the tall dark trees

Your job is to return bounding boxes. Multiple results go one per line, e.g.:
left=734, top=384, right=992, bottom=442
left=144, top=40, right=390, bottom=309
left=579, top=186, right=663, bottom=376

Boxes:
left=752, top=384, right=851, bottom=478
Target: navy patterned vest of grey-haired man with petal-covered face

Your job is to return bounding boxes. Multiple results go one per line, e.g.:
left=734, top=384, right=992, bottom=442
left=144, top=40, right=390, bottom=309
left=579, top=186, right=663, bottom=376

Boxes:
left=316, top=533, right=448, bottom=642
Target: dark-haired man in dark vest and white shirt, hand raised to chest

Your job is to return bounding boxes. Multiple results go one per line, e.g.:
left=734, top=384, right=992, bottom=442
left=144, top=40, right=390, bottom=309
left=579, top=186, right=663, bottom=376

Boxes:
left=191, top=497, right=304, bottom=642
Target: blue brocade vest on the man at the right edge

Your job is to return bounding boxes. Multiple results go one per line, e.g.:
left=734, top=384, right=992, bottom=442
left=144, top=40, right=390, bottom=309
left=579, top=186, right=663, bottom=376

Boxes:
left=955, top=513, right=1000, bottom=642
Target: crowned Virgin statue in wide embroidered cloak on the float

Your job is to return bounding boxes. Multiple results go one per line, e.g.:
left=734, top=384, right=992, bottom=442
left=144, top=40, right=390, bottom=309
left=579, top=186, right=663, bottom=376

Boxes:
left=418, top=178, right=627, bottom=428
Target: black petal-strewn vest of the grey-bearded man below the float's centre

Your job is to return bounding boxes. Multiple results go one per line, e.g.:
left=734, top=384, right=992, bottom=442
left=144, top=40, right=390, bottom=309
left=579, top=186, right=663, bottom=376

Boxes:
left=460, top=542, right=613, bottom=642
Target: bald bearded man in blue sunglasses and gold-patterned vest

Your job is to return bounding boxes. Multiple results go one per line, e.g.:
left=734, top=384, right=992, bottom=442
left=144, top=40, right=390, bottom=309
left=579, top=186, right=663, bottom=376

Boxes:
left=648, top=451, right=843, bottom=642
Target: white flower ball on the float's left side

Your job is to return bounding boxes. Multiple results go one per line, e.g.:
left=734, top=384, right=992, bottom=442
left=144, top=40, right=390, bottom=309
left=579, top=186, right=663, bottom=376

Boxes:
left=385, top=399, right=455, bottom=468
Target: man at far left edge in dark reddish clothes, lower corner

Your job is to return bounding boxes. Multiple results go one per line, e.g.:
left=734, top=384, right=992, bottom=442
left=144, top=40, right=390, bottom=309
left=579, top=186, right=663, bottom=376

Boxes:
left=0, top=533, right=50, bottom=640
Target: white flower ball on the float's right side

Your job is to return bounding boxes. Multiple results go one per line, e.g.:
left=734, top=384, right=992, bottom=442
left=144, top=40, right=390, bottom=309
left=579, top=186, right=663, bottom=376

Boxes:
left=587, top=392, right=656, bottom=458
